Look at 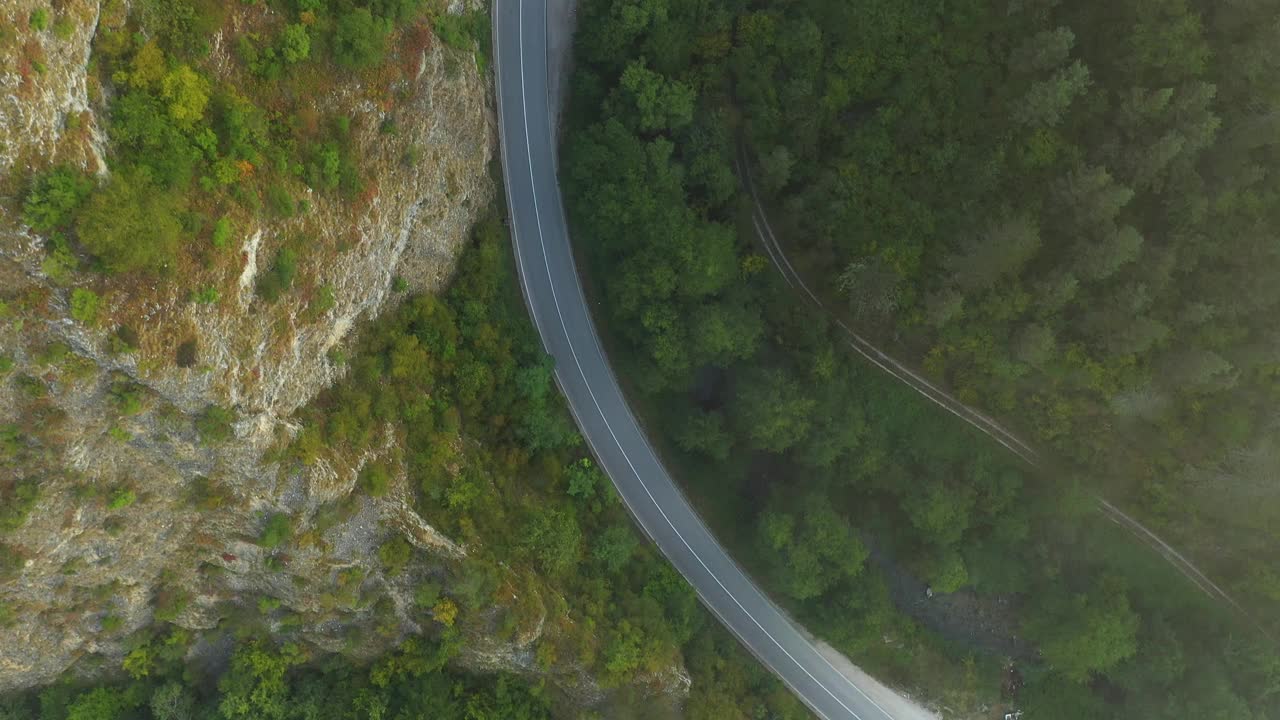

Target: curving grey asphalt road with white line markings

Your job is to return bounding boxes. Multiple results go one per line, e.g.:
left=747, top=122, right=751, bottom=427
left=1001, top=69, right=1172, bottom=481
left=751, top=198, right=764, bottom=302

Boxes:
left=493, top=0, right=904, bottom=720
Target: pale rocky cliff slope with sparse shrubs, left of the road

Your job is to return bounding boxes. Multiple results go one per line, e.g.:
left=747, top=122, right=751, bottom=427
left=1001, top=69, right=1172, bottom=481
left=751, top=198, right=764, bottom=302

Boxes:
left=0, top=0, right=529, bottom=691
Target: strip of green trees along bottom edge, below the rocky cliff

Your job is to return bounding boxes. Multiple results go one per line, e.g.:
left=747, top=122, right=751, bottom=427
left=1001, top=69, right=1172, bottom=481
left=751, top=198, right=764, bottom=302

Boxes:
left=0, top=632, right=552, bottom=720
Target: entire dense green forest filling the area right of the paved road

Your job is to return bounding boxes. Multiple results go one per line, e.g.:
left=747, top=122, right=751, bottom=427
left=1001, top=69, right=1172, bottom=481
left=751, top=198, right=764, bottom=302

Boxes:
left=562, top=0, right=1280, bottom=719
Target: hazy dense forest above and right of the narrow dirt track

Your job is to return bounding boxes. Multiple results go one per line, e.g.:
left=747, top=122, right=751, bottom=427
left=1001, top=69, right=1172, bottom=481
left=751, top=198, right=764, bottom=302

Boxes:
left=728, top=0, right=1280, bottom=589
